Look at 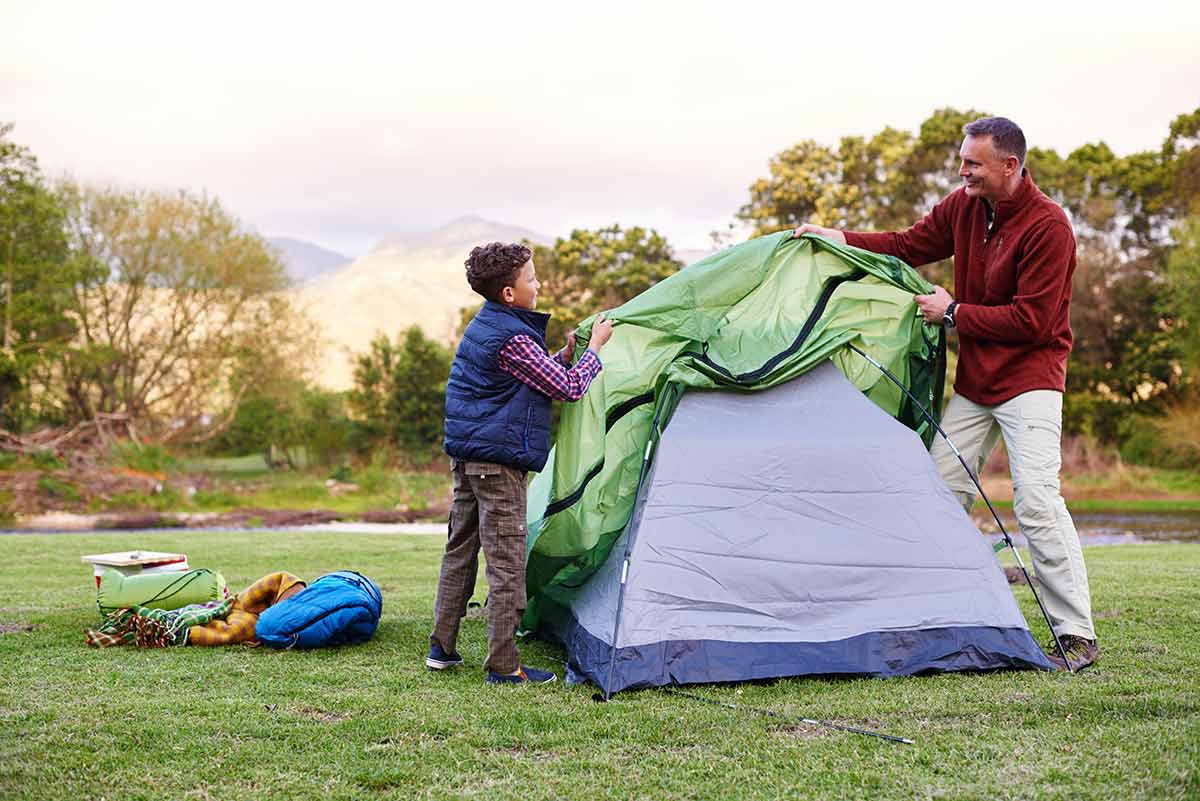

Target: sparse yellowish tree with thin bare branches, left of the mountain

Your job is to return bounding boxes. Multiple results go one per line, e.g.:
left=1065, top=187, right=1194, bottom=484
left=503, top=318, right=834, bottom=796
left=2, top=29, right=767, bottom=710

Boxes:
left=41, top=183, right=313, bottom=442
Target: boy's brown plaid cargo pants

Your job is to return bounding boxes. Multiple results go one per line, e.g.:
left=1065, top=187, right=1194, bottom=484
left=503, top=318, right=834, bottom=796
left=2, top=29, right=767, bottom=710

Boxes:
left=430, top=459, right=526, bottom=673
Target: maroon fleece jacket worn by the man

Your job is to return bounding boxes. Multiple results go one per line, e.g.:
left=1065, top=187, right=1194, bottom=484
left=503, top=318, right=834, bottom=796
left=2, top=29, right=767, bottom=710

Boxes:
left=846, top=171, right=1075, bottom=406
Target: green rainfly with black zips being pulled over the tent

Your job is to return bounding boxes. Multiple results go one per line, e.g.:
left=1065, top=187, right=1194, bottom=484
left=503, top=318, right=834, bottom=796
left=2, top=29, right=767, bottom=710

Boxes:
left=523, top=231, right=946, bottom=631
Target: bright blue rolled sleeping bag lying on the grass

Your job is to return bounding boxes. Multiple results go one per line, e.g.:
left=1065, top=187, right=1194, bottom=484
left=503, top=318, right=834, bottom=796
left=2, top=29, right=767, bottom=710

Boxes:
left=254, top=570, right=383, bottom=648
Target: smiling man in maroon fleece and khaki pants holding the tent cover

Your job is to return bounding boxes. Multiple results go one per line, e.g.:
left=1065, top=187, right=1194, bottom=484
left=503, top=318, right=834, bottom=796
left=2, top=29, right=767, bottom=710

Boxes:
left=793, top=118, right=1099, bottom=670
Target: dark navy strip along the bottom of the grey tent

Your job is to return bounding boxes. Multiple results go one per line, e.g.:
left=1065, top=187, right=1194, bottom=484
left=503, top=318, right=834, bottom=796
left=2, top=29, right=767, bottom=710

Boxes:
left=547, top=599, right=1054, bottom=693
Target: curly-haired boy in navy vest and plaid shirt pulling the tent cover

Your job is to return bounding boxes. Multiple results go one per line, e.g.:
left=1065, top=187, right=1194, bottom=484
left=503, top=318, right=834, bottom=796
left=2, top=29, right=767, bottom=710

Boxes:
left=425, top=242, right=612, bottom=683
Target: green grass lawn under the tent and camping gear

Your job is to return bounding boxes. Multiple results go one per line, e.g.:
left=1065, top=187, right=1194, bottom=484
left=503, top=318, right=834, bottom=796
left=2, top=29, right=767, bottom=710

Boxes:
left=0, top=531, right=1200, bottom=801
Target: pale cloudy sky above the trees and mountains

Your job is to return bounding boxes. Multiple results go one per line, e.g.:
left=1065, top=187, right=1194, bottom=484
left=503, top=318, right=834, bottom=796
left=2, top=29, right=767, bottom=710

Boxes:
left=0, top=0, right=1200, bottom=257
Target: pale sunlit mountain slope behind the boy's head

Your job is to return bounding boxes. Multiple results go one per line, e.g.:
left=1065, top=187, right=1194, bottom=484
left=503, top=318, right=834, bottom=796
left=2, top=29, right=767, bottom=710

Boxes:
left=293, top=217, right=553, bottom=390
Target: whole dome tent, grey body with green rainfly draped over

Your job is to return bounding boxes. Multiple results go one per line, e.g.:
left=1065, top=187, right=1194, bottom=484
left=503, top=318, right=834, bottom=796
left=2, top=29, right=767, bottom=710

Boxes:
left=523, top=234, right=1050, bottom=693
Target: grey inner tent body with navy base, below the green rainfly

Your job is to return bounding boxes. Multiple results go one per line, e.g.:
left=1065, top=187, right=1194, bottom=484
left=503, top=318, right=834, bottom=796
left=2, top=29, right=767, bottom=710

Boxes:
left=545, top=363, right=1051, bottom=693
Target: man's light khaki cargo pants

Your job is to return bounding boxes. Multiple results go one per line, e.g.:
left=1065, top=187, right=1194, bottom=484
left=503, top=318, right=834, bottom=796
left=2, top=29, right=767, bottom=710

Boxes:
left=930, top=390, right=1096, bottom=639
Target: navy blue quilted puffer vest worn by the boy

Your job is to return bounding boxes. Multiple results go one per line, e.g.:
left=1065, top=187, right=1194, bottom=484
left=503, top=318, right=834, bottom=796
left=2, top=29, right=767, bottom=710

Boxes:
left=445, top=301, right=551, bottom=472
